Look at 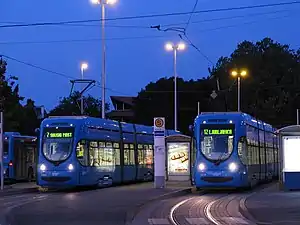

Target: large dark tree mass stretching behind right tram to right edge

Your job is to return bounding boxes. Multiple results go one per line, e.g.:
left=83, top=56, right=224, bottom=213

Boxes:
left=135, top=38, right=300, bottom=132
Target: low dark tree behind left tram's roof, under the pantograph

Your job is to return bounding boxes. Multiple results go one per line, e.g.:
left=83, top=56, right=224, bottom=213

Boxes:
left=49, top=91, right=109, bottom=117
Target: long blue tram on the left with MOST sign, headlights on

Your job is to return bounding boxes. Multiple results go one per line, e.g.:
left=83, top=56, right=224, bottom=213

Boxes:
left=37, top=116, right=178, bottom=188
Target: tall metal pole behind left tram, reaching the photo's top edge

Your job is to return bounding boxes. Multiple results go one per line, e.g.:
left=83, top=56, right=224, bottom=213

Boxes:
left=101, top=0, right=106, bottom=119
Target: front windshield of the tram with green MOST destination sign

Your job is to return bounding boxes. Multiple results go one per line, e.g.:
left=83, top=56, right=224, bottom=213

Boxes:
left=42, top=127, right=74, bottom=162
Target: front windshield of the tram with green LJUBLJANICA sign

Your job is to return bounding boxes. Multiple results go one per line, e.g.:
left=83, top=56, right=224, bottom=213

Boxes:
left=200, top=124, right=234, bottom=161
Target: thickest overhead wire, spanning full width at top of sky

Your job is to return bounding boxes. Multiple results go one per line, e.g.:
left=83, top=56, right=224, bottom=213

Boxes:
left=0, top=1, right=300, bottom=28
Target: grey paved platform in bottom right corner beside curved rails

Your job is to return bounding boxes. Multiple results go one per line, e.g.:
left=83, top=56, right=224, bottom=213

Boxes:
left=245, top=183, right=300, bottom=225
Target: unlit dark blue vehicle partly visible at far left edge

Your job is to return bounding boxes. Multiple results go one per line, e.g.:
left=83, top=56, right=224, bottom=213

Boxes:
left=3, top=132, right=37, bottom=181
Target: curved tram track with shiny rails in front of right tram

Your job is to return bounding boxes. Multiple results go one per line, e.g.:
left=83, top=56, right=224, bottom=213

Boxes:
left=130, top=188, right=254, bottom=225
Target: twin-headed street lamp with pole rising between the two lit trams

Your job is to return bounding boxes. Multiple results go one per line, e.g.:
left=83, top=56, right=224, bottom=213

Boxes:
left=165, top=42, right=186, bottom=131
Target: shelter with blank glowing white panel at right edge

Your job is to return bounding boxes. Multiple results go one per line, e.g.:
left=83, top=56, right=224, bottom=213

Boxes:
left=276, top=125, right=300, bottom=190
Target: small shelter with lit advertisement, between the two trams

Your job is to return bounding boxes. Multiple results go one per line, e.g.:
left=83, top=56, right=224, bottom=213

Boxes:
left=165, top=134, right=192, bottom=181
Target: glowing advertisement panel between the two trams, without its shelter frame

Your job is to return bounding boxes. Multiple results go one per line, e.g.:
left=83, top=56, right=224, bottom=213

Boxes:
left=167, top=142, right=190, bottom=175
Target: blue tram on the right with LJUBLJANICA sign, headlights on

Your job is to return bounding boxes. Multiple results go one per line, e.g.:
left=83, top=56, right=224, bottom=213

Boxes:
left=193, top=112, right=279, bottom=189
